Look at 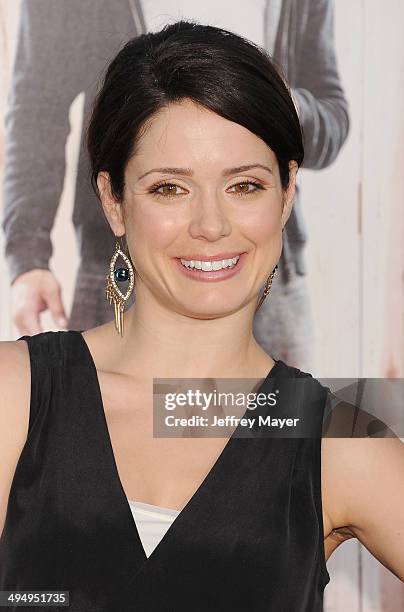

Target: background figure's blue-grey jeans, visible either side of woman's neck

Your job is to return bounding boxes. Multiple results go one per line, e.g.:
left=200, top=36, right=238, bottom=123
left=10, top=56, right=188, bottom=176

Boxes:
left=69, top=267, right=314, bottom=373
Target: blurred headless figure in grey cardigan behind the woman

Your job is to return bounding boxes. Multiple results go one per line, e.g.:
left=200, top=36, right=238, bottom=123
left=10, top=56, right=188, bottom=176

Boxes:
left=2, top=0, right=349, bottom=371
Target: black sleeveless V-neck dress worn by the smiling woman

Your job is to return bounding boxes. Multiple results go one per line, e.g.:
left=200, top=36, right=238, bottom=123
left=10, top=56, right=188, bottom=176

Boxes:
left=0, top=331, right=330, bottom=612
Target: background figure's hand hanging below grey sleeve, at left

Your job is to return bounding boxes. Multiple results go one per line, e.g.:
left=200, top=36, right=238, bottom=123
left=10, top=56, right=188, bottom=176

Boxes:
left=11, top=269, right=67, bottom=336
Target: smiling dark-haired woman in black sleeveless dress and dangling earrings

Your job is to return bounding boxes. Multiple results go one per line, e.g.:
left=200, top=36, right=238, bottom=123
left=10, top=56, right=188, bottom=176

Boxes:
left=0, top=22, right=404, bottom=612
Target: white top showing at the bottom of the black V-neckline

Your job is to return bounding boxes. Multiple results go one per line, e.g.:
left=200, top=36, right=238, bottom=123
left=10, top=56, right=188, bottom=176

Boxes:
left=128, top=500, right=180, bottom=557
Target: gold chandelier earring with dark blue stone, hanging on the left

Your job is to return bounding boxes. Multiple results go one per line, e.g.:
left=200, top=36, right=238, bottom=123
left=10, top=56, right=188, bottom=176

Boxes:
left=105, top=241, right=135, bottom=337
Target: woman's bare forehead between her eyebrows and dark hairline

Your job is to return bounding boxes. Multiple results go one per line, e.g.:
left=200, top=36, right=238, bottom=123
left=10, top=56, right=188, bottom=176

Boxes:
left=130, top=100, right=276, bottom=172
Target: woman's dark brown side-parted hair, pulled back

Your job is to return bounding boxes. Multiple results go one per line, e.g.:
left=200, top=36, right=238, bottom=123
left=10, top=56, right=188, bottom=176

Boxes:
left=87, top=21, right=304, bottom=202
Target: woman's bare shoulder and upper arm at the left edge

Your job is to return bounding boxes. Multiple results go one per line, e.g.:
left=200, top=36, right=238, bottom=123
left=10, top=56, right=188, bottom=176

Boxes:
left=0, top=340, right=31, bottom=533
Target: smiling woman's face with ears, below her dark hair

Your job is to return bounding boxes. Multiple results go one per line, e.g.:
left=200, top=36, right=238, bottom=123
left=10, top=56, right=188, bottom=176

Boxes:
left=98, top=100, right=297, bottom=318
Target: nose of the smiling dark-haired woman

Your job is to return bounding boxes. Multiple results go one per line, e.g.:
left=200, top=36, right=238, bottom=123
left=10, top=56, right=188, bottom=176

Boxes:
left=189, top=193, right=232, bottom=241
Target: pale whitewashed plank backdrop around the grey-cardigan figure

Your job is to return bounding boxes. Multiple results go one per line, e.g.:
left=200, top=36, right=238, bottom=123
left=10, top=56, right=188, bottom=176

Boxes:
left=0, top=0, right=404, bottom=612
